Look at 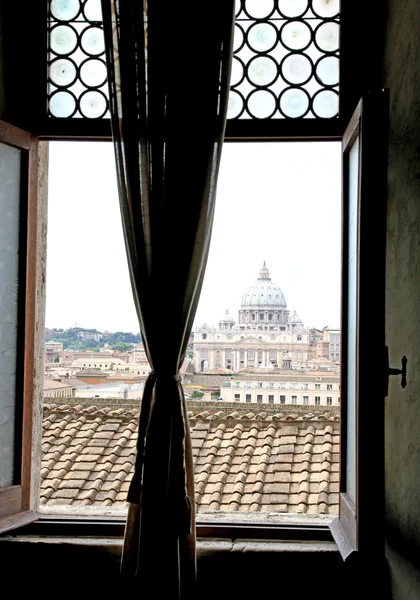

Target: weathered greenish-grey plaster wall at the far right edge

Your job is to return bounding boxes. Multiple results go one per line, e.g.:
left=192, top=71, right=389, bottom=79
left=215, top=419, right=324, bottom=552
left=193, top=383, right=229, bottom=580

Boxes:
left=384, top=0, right=420, bottom=600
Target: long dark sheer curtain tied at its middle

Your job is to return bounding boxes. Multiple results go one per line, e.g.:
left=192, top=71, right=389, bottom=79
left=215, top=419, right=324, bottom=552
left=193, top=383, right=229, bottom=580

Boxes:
left=102, top=0, right=234, bottom=600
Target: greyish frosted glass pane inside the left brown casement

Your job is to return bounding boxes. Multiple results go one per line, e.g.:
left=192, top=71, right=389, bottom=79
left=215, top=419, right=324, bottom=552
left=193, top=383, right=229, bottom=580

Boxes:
left=0, top=143, right=21, bottom=487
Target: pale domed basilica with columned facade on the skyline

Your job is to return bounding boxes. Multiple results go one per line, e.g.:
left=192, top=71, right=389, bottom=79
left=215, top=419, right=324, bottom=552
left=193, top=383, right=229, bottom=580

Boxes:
left=194, top=262, right=340, bottom=372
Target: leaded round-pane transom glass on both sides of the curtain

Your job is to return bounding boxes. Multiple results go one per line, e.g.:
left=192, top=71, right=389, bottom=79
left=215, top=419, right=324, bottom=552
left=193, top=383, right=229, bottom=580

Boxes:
left=48, top=0, right=340, bottom=119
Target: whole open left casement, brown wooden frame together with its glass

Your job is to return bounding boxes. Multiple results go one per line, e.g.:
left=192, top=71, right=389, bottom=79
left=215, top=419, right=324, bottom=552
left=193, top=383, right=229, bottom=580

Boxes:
left=0, top=122, right=39, bottom=532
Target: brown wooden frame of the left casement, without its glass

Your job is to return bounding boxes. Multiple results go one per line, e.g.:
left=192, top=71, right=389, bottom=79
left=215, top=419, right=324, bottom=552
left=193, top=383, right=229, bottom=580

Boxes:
left=0, top=121, right=38, bottom=532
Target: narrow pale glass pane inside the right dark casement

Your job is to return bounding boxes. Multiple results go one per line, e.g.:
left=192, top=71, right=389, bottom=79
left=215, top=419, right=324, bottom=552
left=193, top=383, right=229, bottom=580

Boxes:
left=346, top=138, right=359, bottom=503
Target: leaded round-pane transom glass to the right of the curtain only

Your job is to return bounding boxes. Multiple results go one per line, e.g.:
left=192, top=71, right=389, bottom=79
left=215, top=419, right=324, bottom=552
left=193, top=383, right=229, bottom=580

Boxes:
left=233, top=0, right=340, bottom=119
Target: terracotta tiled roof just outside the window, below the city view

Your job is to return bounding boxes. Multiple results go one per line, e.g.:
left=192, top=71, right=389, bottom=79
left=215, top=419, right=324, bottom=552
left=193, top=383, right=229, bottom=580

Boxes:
left=40, top=402, right=339, bottom=515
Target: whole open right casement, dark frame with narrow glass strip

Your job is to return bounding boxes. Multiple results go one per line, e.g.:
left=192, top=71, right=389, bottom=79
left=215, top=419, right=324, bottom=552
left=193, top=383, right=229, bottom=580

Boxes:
left=331, top=91, right=389, bottom=559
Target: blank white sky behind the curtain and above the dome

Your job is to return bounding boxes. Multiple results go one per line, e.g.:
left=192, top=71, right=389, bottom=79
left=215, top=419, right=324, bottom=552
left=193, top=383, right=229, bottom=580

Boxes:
left=46, top=142, right=341, bottom=332
